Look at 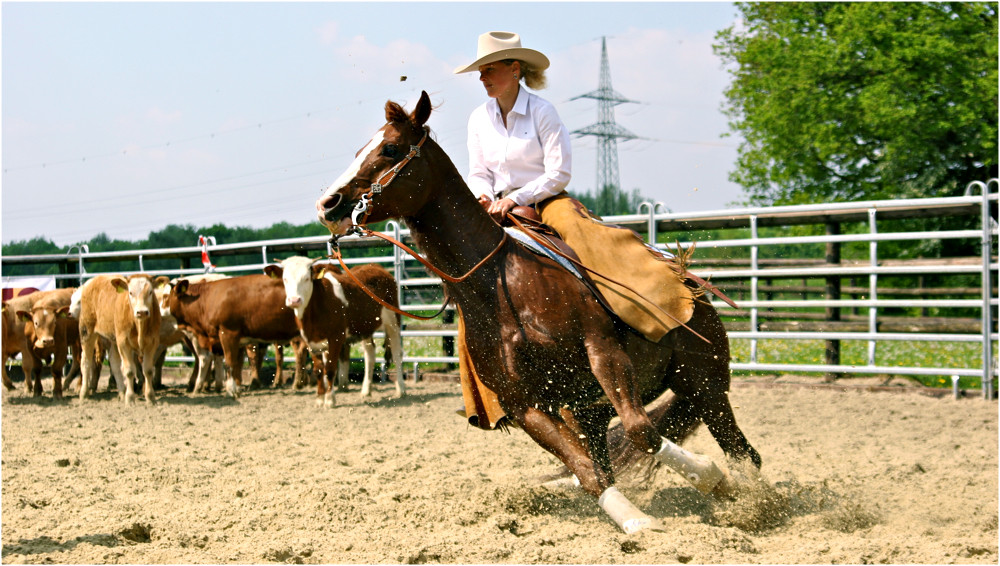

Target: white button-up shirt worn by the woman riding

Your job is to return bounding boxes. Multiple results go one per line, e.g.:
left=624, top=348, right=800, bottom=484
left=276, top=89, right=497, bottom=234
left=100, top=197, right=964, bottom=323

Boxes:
left=468, top=87, right=573, bottom=206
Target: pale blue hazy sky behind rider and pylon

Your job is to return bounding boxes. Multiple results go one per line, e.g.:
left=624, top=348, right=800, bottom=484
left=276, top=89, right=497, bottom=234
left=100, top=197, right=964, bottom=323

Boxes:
left=0, top=1, right=741, bottom=247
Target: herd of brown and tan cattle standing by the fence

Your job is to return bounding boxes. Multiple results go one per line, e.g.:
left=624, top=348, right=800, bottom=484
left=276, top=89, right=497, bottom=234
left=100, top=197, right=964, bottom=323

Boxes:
left=2, top=256, right=405, bottom=407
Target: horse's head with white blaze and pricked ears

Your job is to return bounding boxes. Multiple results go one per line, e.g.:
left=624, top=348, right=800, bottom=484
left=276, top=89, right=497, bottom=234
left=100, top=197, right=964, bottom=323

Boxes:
left=316, top=92, right=432, bottom=236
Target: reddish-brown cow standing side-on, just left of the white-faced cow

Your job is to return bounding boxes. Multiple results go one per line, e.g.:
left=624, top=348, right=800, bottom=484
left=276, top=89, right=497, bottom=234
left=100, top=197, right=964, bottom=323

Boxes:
left=168, top=275, right=299, bottom=397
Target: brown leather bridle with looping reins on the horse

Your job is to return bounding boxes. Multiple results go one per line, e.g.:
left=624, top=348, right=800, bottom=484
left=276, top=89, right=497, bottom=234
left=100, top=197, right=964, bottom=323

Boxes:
left=330, top=126, right=508, bottom=320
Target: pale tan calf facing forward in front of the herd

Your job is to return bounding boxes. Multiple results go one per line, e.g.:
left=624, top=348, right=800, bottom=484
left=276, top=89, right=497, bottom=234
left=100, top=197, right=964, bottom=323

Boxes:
left=71, top=274, right=161, bottom=405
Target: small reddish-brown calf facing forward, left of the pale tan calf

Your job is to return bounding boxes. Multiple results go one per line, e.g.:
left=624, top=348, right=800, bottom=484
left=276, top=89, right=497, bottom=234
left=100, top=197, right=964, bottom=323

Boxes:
left=16, top=288, right=81, bottom=399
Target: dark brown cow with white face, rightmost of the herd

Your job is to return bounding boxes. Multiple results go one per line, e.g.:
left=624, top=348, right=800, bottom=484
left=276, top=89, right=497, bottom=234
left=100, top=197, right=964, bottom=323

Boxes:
left=264, top=256, right=406, bottom=407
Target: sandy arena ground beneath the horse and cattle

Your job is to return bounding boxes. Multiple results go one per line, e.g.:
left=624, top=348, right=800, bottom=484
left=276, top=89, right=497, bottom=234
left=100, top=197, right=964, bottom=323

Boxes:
left=2, top=377, right=998, bottom=564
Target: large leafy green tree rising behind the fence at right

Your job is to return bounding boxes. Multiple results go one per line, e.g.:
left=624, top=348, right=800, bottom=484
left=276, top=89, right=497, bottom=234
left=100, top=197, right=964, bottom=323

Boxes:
left=715, top=2, right=997, bottom=205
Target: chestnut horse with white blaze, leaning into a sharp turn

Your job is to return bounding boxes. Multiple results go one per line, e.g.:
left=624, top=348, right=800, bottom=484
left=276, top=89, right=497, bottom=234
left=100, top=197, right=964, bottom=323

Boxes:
left=315, top=92, right=761, bottom=534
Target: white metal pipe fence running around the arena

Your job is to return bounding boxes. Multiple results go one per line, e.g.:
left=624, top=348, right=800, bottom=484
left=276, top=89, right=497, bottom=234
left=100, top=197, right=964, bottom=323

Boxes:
left=2, top=179, right=1000, bottom=398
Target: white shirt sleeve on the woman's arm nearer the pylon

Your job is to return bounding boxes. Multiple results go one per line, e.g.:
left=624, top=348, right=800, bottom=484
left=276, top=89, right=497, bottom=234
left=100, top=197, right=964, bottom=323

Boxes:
left=509, top=102, right=573, bottom=206
